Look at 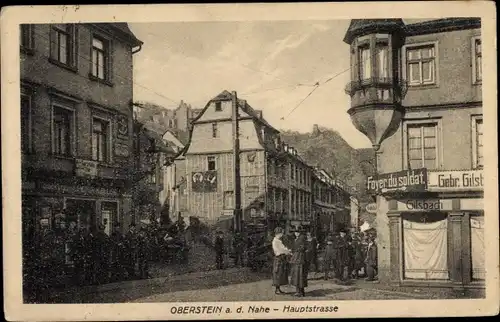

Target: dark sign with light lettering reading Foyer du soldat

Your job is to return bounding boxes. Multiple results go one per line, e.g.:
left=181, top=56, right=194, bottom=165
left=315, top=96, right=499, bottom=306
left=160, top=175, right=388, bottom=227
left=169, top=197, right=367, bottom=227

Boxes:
left=366, top=168, right=427, bottom=193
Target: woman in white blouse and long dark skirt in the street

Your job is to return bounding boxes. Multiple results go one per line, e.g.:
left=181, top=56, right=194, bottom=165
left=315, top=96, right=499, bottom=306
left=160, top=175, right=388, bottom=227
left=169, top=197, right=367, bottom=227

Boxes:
left=272, top=227, right=291, bottom=294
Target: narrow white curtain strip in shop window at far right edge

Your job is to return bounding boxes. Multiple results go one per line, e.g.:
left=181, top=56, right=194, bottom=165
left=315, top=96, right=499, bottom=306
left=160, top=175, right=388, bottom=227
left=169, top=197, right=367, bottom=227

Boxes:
left=470, top=216, right=486, bottom=280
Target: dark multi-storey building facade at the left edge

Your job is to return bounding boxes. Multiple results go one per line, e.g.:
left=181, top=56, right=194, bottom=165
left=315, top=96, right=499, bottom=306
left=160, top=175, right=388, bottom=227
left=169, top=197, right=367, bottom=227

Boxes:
left=20, top=23, right=142, bottom=234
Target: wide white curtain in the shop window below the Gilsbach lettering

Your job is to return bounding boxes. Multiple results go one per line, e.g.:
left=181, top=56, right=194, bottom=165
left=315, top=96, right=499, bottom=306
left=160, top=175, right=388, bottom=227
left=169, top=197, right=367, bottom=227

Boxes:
left=403, top=218, right=448, bottom=280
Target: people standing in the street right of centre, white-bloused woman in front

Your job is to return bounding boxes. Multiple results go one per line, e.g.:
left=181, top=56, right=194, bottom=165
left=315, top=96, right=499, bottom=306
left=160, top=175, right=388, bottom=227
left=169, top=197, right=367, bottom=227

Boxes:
left=272, top=227, right=377, bottom=297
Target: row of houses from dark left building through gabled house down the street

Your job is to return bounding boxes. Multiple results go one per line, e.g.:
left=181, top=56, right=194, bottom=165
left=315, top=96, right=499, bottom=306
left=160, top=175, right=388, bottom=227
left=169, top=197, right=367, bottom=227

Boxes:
left=20, top=23, right=356, bottom=238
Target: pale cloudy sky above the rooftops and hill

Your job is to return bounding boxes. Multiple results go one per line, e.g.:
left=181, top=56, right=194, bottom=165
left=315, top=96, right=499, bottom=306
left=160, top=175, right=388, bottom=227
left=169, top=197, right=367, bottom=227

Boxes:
left=129, top=20, right=371, bottom=148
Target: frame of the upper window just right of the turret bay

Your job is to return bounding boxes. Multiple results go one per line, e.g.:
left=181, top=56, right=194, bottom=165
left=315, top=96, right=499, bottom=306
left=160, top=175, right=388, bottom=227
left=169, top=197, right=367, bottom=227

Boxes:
left=401, top=41, right=439, bottom=88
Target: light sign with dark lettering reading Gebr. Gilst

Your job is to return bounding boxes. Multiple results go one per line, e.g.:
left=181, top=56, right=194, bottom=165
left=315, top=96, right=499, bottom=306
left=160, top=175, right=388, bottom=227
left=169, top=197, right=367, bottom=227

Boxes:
left=428, top=170, right=484, bottom=191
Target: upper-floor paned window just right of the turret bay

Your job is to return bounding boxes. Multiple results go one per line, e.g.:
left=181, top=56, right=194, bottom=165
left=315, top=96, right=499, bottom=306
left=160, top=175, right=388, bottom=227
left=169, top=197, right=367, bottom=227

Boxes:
left=406, top=45, right=436, bottom=86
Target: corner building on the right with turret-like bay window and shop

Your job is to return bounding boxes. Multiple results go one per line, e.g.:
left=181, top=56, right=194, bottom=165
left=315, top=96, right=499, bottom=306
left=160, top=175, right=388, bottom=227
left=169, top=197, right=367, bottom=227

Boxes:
left=344, top=18, right=485, bottom=287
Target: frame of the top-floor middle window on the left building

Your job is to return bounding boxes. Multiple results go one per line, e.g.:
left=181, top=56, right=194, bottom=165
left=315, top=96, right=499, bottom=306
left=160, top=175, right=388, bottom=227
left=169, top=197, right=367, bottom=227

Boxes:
left=49, top=24, right=78, bottom=71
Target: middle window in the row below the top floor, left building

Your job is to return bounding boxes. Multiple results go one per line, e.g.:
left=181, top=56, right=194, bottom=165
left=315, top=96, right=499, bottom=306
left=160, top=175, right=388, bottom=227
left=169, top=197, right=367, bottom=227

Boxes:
left=52, top=106, right=73, bottom=156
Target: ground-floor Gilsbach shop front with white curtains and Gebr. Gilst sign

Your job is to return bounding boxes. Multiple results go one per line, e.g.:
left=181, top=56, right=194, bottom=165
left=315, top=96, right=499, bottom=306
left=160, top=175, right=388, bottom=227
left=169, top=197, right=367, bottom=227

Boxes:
left=385, top=170, right=485, bottom=287
